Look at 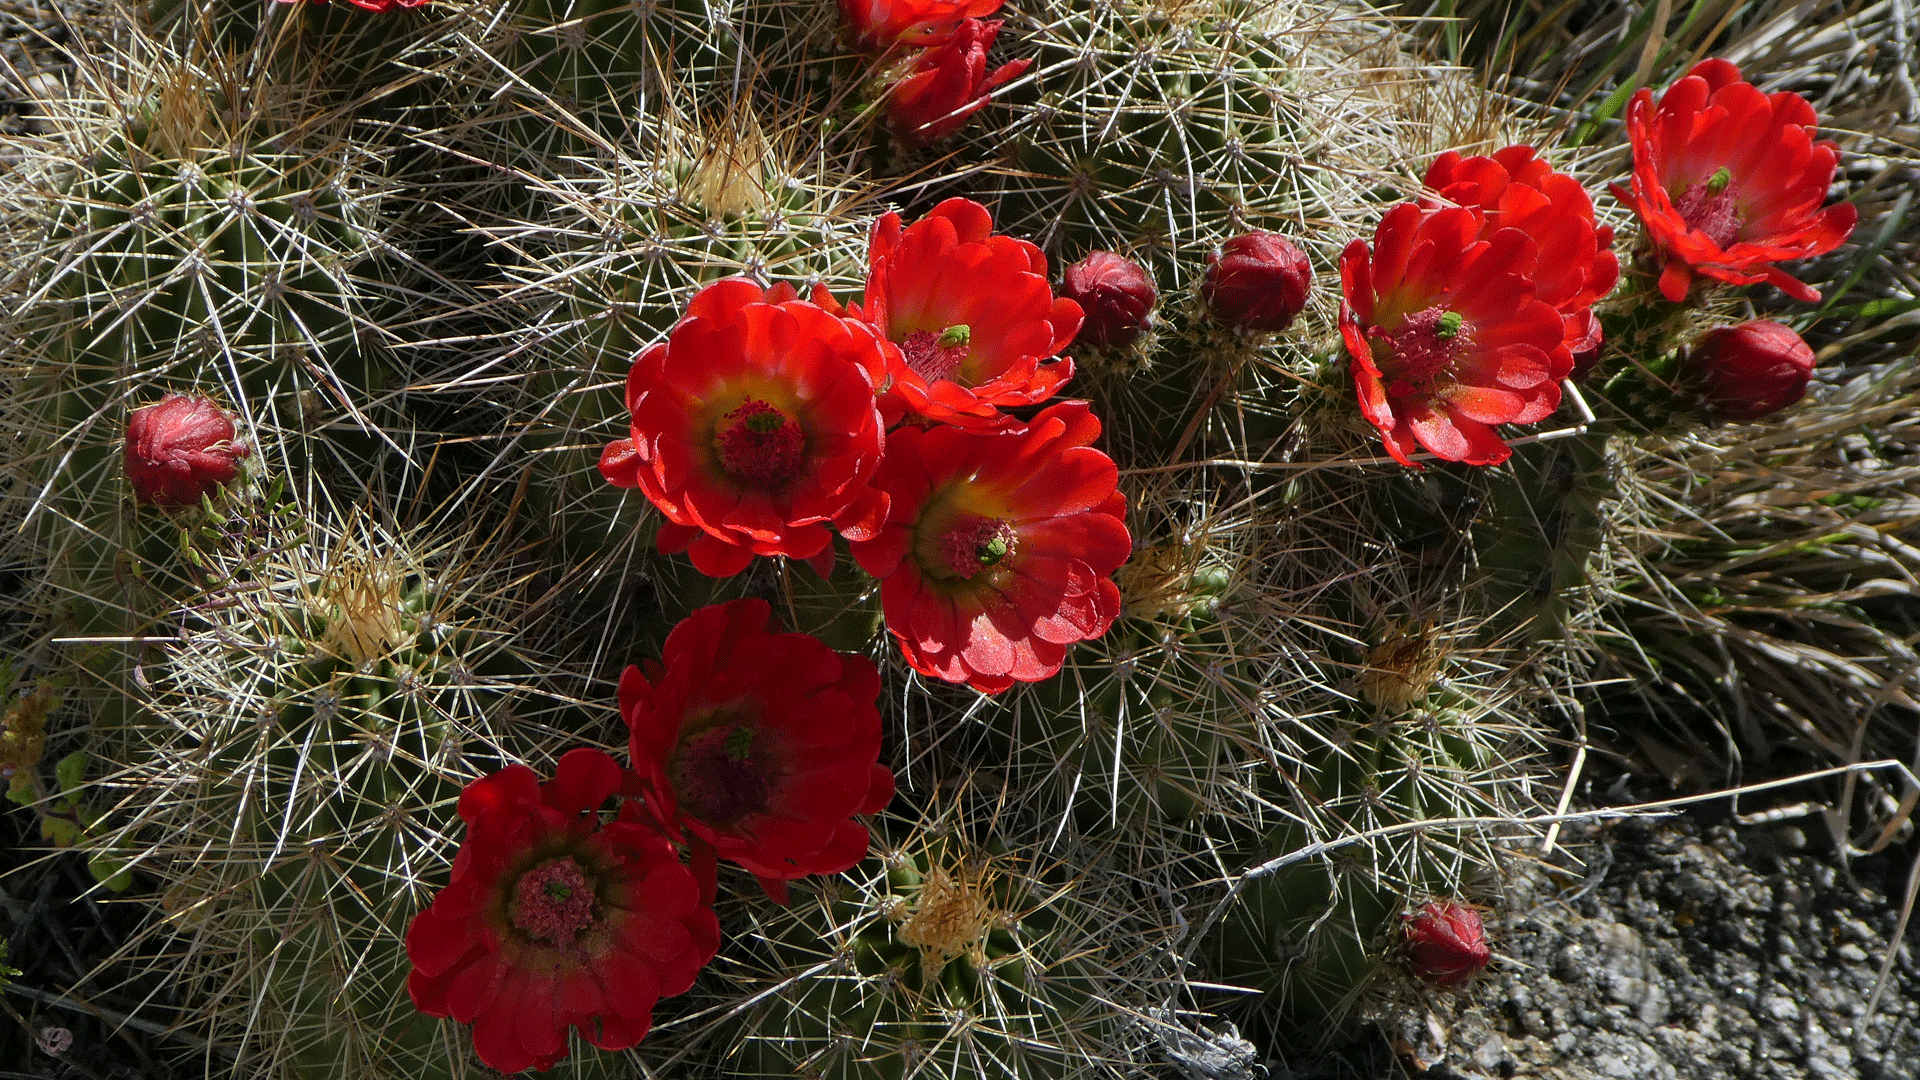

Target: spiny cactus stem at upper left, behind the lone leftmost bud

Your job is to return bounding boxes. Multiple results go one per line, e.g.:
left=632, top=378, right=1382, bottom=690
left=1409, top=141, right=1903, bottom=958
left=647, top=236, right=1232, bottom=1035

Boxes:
left=8, top=96, right=384, bottom=684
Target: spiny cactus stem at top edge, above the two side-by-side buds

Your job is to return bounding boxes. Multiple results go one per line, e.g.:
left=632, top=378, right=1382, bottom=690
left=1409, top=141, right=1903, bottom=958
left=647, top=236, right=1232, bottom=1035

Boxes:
left=1000, top=2, right=1311, bottom=269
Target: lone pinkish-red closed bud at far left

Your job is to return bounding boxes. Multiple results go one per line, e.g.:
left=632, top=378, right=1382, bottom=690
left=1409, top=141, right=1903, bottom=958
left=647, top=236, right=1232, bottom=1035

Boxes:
left=127, top=394, right=248, bottom=505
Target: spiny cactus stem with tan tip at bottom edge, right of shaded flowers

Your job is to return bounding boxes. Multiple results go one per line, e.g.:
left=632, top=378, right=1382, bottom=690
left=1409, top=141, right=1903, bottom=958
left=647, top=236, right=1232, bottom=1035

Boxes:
left=735, top=836, right=1114, bottom=1080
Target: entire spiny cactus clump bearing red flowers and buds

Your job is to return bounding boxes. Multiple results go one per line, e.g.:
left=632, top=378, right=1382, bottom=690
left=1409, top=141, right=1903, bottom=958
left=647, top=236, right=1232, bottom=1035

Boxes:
left=0, top=0, right=1873, bottom=1080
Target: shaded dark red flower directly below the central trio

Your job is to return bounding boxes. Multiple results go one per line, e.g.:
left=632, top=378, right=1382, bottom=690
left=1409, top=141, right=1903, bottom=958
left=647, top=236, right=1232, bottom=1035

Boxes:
left=620, top=600, right=893, bottom=901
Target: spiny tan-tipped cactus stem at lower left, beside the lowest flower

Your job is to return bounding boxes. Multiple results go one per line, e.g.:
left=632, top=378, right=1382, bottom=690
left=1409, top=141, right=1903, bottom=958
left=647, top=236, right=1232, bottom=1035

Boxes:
left=86, top=507, right=597, bottom=1080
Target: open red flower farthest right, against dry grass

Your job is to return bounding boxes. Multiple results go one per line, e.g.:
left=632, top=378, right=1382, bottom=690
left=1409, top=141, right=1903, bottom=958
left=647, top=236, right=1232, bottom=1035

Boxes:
left=1613, top=60, right=1859, bottom=304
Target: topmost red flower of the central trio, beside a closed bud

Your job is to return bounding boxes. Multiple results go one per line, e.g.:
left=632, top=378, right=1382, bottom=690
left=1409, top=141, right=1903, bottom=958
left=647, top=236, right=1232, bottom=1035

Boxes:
left=847, top=198, right=1081, bottom=427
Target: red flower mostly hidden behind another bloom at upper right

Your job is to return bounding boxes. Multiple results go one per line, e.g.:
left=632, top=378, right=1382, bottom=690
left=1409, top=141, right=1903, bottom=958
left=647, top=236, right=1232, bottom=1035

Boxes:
left=1421, top=146, right=1620, bottom=361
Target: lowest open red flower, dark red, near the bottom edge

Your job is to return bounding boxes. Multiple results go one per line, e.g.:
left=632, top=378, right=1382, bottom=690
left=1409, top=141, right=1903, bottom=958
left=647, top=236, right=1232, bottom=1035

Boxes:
left=407, top=749, right=720, bottom=1072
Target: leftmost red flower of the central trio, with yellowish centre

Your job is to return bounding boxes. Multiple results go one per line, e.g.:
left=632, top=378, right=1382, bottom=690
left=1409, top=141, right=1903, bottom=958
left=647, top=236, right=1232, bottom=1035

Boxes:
left=599, top=279, right=899, bottom=577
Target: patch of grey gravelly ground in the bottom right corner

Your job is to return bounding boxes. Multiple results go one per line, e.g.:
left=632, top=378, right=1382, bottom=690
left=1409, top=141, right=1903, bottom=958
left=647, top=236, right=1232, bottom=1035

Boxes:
left=1344, top=817, right=1920, bottom=1080
